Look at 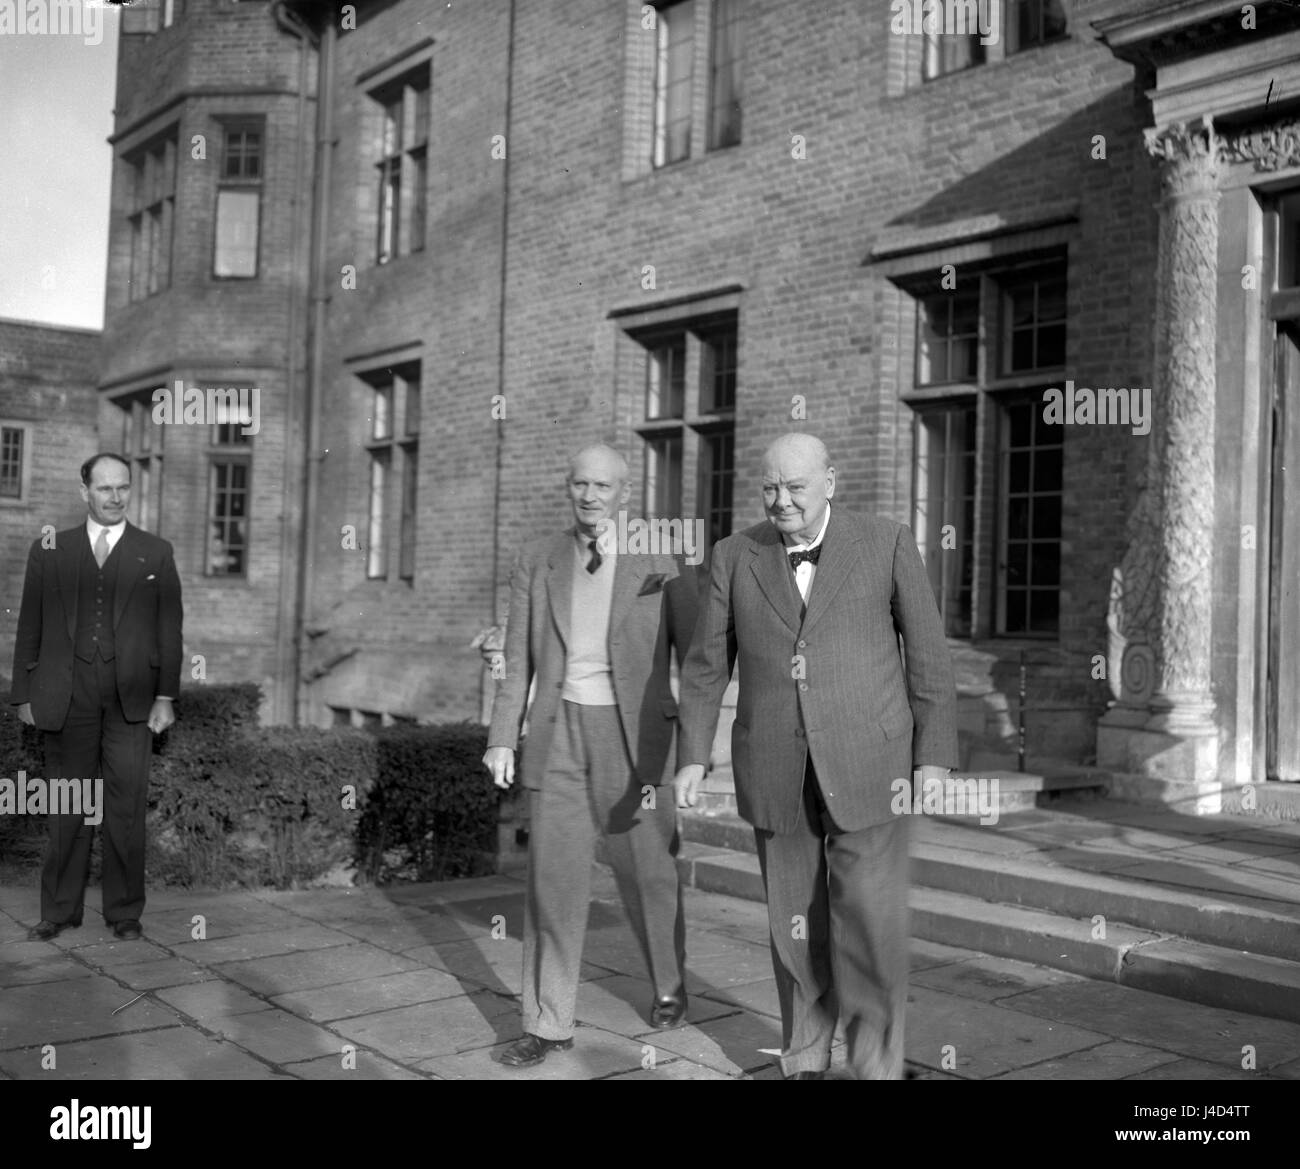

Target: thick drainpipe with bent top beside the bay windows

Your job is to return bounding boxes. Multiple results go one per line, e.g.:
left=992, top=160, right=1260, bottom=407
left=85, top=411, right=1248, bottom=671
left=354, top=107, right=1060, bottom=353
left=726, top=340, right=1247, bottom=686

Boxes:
left=270, top=0, right=316, bottom=723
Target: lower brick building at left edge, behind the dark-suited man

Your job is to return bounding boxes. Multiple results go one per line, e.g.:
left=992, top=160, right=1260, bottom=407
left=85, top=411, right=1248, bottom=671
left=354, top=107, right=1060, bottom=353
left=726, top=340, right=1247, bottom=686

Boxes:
left=0, top=320, right=100, bottom=663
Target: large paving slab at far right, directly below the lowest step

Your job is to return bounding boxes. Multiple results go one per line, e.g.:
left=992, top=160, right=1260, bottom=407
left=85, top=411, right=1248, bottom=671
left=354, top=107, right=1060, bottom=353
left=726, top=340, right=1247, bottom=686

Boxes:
left=1014, top=982, right=1300, bottom=1069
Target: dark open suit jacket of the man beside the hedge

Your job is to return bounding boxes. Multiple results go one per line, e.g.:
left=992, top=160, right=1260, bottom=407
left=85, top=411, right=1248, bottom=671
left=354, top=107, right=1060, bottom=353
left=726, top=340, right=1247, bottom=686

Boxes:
left=9, top=523, right=183, bottom=731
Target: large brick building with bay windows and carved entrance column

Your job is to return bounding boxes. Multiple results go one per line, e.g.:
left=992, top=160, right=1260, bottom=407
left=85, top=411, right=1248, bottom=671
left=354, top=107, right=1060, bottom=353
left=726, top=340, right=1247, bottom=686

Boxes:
left=83, top=0, right=1300, bottom=808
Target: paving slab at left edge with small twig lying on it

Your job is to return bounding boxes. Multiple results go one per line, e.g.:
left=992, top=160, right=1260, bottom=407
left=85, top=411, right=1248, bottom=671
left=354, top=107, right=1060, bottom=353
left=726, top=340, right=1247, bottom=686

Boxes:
left=0, top=975, right=177, bottom=1049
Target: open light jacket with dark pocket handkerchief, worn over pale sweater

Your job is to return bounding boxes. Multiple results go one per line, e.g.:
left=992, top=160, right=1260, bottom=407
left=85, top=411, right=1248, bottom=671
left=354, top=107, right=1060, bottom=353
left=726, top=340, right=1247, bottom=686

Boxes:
left=488, top=528, right=698, bottom=788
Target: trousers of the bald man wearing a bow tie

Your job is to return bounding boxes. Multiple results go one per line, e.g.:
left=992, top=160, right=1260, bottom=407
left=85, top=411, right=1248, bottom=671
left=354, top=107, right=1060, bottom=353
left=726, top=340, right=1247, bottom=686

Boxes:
left=754, top=761, right=910, bottom=1079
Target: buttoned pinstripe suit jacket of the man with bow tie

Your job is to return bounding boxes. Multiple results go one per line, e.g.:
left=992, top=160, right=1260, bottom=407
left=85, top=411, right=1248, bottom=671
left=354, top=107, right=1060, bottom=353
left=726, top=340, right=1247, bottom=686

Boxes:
left=677, top=506, right=957, bottom=832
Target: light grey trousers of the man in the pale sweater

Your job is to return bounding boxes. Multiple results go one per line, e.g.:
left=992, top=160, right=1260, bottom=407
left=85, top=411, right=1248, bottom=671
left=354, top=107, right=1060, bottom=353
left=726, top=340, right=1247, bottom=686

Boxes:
left=523, top=702, right=686, bottom=1039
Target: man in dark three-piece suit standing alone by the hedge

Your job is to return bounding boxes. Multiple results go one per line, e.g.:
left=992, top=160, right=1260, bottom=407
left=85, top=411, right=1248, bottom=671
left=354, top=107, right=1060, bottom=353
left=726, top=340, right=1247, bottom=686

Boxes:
left=10, top=454, right=183, bottom=940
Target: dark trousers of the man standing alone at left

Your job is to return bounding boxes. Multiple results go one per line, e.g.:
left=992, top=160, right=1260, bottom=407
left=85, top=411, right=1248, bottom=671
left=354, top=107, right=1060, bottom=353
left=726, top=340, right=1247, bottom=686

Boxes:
left=40, top=657, right=153, bottom=922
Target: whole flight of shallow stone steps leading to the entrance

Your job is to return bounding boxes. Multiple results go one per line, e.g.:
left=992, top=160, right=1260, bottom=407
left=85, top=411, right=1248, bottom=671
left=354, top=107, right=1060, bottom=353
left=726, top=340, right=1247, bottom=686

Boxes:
left=679, top=795, right=1300, bottom=1022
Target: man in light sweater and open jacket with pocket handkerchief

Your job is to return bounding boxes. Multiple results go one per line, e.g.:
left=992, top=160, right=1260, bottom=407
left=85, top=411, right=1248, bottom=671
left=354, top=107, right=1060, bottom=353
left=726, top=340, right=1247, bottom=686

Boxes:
left=484, top=446, right=697, bottom=1068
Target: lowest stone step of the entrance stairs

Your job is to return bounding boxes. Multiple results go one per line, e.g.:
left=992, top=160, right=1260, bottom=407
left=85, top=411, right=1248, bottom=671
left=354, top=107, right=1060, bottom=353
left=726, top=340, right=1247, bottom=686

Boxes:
left=677, top=843, right=1300, bottom=1022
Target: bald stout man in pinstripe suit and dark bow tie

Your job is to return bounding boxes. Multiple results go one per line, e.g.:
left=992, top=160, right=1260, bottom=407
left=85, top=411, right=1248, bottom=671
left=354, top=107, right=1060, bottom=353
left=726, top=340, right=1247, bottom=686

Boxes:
left=675, top=434, right=957, bottom=1079
